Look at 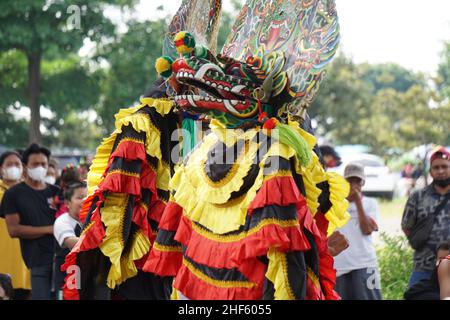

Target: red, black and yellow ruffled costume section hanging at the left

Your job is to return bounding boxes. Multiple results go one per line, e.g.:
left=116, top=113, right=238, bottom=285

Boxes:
left=62, top=98, right=173, bottom=299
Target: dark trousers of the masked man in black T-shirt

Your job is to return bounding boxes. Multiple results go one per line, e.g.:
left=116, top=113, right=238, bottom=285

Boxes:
left=31, top=264, right=54, bottom=300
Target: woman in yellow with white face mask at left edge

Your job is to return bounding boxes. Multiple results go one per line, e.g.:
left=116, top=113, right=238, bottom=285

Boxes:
left=0, top=151, right=31, bottom=299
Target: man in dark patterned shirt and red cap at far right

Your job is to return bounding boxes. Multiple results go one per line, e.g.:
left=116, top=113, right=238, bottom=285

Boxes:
left=402, top=147, right=450, bottom=286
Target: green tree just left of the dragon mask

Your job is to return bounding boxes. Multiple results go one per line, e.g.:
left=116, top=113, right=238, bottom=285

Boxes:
left=96, top=19, right=167, bottom=133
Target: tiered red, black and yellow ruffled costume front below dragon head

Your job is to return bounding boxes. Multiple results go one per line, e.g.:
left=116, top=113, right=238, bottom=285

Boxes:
left=145, top=124, right=342, bottom=299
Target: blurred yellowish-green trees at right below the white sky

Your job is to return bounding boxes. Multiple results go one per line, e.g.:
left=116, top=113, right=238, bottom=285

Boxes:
left=310, top=51, right=450, bottom=155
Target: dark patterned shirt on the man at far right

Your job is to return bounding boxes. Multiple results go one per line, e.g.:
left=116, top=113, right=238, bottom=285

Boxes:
left=402, top=185, right=450, bottom=271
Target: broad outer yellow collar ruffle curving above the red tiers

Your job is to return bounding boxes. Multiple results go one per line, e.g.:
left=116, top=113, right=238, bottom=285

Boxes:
left=170, top=140, right=295, bottom=234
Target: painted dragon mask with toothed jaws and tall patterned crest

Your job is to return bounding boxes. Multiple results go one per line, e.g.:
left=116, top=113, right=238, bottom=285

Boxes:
left=156, top=0, right=339, bottom=128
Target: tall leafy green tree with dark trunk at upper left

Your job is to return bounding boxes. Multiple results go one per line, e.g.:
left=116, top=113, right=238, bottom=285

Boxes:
left=0, top=0, right=133, bottom=142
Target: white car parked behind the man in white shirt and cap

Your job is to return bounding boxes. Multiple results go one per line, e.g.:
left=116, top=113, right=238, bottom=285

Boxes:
left=329, top=153, right=397, bottom=199
